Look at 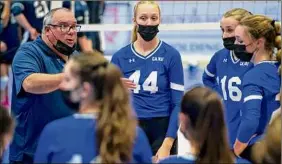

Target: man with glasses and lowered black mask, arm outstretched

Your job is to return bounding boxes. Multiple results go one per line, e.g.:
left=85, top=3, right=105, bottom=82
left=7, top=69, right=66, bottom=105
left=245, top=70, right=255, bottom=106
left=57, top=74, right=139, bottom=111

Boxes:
left=10, top=8, right=80, bottom=163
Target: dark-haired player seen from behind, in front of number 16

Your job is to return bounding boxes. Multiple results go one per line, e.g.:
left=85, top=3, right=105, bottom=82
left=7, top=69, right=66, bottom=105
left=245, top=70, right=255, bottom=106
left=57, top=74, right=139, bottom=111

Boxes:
left=160, top=87, right=233, bottom=163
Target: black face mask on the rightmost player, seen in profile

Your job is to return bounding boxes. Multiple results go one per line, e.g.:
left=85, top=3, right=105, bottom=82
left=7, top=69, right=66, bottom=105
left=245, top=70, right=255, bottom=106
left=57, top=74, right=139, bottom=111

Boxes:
left=234, top=44, right=254, bottom=62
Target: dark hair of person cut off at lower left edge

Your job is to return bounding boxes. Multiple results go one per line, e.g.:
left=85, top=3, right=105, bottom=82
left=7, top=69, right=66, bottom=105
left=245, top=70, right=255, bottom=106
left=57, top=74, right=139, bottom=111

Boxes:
left=0, top=105, right=15, bottom=160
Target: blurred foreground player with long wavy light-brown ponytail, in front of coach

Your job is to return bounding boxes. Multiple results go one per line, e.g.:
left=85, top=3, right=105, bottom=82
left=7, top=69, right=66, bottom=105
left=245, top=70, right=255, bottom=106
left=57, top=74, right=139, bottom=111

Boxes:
left=34, top=53, right=152, bottom=163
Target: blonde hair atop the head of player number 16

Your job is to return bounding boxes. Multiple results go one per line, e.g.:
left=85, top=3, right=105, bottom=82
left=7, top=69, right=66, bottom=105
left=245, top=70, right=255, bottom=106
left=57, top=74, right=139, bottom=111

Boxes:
left=223, top=8, right=252, bottom=22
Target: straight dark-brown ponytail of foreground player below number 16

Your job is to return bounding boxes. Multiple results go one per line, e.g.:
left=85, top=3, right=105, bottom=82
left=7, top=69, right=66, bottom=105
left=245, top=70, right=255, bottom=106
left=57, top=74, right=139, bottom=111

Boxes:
left=195, top=93, right=233, bottom=163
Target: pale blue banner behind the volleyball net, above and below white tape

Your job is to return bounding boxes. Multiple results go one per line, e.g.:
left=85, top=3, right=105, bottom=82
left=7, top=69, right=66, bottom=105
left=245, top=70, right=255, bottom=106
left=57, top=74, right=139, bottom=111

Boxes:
left=103, top=1, right=281, bottom=57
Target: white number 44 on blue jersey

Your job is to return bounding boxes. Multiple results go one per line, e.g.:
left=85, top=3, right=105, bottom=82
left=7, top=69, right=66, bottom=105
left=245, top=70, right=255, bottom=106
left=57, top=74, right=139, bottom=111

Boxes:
left=128, top=70, right=159, bottom=94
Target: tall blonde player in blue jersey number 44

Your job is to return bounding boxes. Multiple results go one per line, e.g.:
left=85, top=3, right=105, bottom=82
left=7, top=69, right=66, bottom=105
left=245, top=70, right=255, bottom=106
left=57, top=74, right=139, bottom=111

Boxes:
left=112, top=1, right=184, bottom=158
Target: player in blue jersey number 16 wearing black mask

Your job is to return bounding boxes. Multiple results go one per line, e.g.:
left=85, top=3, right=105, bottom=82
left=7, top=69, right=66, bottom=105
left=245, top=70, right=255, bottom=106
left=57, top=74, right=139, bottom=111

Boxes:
left=203, top=8, right=252, bottom=149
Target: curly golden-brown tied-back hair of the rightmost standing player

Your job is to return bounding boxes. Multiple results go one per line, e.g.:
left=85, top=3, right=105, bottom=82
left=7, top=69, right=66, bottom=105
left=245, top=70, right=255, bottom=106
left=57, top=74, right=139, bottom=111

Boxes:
left=240, top=15, right=281, bottom=68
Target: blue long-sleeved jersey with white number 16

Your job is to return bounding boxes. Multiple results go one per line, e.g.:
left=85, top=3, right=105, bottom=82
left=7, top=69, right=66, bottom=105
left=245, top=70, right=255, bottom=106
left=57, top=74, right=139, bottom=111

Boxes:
left=203, top=48, right=253, bottom=148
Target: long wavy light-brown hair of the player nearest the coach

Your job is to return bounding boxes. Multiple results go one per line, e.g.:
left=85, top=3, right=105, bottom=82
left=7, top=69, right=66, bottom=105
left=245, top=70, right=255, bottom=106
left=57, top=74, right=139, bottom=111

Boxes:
left=71, top=52, right=137, bottom=163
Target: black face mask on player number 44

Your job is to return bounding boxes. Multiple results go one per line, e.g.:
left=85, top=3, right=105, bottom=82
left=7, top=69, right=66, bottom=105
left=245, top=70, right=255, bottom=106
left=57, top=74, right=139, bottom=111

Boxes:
left=137, top=24, right=159, bottom=42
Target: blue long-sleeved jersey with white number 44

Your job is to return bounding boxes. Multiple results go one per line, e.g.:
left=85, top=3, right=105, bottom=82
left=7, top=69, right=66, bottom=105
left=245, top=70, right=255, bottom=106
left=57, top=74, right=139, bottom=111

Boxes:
left=111, top=41, right=184, bottom=138
